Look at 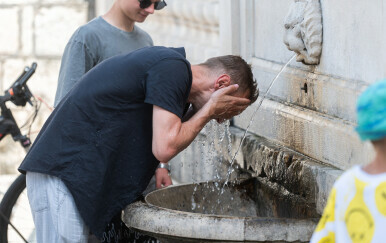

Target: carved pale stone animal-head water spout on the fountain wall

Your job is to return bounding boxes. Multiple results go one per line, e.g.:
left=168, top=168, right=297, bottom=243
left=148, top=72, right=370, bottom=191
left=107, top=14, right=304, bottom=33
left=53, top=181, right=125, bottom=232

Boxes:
left=284, top=0, right=323, bottom=65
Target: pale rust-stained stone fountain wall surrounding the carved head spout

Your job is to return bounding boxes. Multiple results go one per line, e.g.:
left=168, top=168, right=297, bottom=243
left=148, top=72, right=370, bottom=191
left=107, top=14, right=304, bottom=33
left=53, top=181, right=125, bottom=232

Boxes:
left=225, top=0, right=378, bottom=170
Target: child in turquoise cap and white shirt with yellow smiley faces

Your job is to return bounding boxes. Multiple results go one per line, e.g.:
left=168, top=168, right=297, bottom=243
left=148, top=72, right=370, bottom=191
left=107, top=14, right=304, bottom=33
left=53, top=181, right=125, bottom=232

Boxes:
left=310, top=79, right=386, bottom=243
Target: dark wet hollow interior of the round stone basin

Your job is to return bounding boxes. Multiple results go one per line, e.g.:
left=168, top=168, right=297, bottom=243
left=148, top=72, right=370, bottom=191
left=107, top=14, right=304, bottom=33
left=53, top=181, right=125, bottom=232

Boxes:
left=146, top=178, right=319, bottom=219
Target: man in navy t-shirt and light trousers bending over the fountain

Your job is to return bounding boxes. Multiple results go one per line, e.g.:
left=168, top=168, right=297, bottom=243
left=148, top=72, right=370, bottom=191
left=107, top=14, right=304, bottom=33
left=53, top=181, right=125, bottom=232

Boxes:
left=19, top=47, right=258, bottom=243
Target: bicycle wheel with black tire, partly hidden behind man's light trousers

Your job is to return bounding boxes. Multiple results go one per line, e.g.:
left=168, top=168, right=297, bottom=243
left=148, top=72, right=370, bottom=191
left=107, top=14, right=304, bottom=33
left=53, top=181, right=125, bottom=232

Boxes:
left=0, top=175, right=36, bottom=243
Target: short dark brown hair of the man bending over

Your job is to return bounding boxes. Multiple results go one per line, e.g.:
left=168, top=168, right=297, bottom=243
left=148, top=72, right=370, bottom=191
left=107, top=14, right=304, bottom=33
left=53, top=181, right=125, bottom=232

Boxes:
left=200, top=55, right=259, bottom=103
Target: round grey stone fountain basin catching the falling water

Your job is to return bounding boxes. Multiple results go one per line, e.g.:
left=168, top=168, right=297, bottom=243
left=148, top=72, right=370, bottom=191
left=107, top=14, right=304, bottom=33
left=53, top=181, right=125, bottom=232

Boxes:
left=122, top=178, right=319, bottom=243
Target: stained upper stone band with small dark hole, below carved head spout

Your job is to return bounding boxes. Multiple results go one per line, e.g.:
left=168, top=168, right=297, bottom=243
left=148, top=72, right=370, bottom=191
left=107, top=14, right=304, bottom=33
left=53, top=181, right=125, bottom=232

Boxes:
left=251, top=58, right=367, bottom=123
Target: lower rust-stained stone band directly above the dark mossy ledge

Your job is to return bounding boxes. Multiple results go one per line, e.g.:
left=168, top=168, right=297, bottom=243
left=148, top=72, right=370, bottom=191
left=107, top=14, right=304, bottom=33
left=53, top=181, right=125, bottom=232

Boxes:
left=235, top=99, right=374, bottom=170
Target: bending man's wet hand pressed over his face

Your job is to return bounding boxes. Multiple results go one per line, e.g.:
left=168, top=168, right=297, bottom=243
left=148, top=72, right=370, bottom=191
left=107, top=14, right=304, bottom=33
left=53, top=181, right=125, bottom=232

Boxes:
left=207, top=84, right=251, bottom=122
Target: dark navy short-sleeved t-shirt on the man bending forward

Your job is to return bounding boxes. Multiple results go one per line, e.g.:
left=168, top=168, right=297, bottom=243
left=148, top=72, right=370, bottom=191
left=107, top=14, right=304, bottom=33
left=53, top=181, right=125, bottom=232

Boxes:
left=19, top=47, right=192, bottom=236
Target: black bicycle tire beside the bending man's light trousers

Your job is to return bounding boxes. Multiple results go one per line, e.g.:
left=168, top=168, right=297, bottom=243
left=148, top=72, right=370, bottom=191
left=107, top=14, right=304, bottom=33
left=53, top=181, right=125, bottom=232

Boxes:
left=0, top=174, right=30, bottom=243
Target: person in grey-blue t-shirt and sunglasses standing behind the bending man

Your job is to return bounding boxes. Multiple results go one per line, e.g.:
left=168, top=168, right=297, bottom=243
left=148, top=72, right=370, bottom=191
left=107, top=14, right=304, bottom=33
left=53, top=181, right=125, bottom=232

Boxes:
left=54, top=0, right=166, bottom=107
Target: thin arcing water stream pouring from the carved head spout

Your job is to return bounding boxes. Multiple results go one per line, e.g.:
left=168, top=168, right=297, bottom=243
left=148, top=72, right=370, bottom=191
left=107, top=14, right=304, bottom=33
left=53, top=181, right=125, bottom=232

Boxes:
left=221, top=54, right=296, bottom=194
